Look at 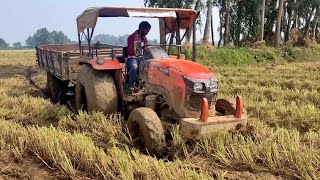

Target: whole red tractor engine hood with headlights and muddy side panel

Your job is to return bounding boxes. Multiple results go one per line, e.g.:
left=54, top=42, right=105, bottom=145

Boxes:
left=147, top=58, right=218, bottom=118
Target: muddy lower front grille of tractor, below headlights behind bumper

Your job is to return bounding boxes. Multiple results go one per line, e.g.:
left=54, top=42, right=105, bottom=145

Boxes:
left=189, top=93, right=217, bottom=111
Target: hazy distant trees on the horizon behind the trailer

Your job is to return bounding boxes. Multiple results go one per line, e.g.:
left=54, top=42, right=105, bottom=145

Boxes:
left=0, top=28, right=158, bottom=49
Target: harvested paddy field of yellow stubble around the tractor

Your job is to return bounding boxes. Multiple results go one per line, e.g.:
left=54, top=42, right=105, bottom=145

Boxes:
left=0, top=50, right=320, bottom=179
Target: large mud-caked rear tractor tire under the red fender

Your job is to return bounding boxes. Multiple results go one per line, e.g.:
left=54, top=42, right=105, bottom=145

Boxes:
left=75, top=65, right=118, bottom=114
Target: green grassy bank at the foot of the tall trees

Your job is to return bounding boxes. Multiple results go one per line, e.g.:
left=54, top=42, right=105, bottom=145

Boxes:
left=184, top=44, right=320, bottom=66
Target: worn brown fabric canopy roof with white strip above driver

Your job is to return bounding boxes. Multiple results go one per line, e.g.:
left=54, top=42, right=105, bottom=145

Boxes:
left=77, top=7, right=197, bottom=34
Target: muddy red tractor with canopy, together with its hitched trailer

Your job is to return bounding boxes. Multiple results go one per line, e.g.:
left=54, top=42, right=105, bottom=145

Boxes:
left=37, top=7, right=246, bottom=155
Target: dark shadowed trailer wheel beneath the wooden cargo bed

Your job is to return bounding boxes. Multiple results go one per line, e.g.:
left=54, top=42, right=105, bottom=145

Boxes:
left=47, top=72, right=69, bottom=103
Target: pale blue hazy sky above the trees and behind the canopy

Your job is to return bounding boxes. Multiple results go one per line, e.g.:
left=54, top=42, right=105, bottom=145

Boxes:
left=0, top=0, right=219, bottom=45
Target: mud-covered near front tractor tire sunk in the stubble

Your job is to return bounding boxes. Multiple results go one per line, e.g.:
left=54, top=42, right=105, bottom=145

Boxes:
left=128, top=107, right=166, bottom=157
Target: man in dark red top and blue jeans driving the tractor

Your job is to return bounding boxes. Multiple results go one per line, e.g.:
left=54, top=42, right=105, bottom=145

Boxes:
left=127, top=21, right=151, bottom=92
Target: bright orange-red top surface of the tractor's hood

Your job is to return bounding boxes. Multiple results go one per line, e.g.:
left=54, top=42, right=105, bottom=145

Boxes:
left=152, top=58, right=213, bottom=79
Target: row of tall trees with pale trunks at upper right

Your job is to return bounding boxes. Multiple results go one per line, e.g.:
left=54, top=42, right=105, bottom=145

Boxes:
left=144, top=0, right=320, bottom=46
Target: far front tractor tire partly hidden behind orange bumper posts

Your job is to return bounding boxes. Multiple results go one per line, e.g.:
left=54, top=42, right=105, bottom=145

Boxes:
left=216, top=99, right=247, bottom=117
